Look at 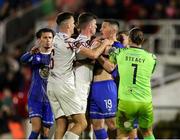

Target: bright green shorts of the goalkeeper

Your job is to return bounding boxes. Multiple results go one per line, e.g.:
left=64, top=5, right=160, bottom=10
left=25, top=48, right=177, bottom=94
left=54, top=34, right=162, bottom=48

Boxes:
left=116, top=100, right=153, bottom=132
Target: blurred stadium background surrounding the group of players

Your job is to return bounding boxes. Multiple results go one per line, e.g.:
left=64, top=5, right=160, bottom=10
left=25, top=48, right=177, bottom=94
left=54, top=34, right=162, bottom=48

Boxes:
left=0, top=0, right=180, bottom=138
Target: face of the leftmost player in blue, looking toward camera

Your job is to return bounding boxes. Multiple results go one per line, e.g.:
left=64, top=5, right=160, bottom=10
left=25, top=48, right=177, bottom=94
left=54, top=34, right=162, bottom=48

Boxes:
left=39, top=32, right=53, bottom=49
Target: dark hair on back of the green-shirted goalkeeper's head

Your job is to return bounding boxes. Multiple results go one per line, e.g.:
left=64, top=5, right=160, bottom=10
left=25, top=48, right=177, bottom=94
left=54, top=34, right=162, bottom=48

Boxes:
left=129, top=27, right=144, bottom=45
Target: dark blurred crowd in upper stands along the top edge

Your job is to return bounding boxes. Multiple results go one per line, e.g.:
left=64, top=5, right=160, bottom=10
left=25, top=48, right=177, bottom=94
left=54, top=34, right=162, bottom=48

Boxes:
left=0, top=0, right=180, bottom=21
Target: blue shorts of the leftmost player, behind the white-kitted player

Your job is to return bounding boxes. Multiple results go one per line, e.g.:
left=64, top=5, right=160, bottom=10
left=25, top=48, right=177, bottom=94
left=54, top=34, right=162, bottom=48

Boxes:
left=28, top=100, right=54, bottom=127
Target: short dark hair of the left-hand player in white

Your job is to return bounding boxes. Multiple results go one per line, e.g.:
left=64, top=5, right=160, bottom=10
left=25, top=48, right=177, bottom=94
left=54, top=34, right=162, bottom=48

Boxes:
left=56, top=12, right=74, bottom=25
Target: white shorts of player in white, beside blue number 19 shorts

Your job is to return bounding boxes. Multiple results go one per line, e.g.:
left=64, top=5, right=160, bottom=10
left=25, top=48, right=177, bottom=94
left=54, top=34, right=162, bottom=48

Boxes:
left=76, top=81, right=90, bottom=113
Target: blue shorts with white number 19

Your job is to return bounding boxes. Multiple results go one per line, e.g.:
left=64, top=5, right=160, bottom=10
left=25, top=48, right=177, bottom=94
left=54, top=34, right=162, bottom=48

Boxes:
left=89, top=80, right=117, bottom=119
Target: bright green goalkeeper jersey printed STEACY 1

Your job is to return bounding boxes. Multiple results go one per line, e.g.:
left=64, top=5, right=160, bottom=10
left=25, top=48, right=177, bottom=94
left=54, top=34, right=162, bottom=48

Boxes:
left=110, top=47, right=156, bottom=102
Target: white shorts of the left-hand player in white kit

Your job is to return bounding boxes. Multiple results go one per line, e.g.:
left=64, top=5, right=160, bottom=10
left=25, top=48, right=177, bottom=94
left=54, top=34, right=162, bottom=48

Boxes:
left=47, top=79, right=83, bottom=119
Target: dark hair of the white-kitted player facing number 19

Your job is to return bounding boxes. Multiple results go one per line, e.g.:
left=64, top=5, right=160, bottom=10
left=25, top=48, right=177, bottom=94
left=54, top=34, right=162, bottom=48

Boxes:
left=77, top=12, right=97, bottom=29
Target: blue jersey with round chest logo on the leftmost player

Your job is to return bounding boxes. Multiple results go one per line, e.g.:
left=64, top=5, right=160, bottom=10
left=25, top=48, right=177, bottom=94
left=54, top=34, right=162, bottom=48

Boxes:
left=21, top=52, right=51, bottom=102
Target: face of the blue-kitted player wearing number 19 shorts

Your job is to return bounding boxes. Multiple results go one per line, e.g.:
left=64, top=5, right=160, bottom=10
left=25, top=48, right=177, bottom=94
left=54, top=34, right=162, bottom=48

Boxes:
left=100, top=22, right=111, bottom=38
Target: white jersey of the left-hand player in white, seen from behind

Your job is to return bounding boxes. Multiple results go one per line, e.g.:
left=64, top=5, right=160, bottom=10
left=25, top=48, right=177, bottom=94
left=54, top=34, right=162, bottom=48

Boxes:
left=48, top=32, right=75, bottom=82
